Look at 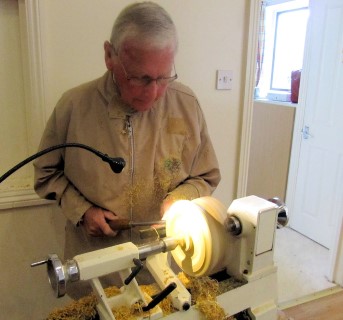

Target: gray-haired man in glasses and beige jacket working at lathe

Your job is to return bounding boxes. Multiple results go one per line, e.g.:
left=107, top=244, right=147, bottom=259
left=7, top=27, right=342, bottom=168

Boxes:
left=34, top=2, right=220, bottom=296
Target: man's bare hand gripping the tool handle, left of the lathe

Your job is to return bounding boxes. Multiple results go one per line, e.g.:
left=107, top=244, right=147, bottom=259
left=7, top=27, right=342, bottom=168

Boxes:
left=83, top=207, right=118, bottom=237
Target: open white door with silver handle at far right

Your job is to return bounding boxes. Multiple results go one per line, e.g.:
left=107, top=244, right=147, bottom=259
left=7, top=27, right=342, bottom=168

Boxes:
left=290, top=0, right=343, bottom=248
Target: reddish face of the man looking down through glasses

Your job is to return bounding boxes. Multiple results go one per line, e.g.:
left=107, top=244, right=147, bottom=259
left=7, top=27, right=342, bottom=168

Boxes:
left=105, top=43, right=174, bottom=111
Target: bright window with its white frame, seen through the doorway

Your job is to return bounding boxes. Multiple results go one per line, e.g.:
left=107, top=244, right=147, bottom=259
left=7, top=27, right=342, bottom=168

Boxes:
left=256, top=0, right=309, bottom=101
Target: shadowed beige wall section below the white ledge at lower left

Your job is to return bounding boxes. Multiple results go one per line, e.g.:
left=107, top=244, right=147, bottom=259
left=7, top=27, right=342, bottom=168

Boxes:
left=0, top=205, right=74, bottom=320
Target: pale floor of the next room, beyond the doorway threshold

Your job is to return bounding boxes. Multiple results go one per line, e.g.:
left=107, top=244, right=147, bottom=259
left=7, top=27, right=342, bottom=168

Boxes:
left=274, top=227, right=336, bottom=306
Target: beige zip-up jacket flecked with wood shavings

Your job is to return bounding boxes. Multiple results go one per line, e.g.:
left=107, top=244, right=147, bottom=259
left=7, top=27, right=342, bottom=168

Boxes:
left=34, top=72, right=220, bottom=252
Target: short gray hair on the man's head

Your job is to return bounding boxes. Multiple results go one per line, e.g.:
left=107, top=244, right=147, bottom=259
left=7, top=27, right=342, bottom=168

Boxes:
left=111, top=1, right=178, bottom=53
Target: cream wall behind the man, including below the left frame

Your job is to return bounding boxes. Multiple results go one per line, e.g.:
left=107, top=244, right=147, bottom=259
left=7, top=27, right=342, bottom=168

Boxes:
left=0, top=0, right=249, bottom=320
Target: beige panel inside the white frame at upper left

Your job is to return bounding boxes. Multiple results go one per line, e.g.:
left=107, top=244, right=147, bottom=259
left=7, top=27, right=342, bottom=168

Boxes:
left=0, top=0, right=32, bottom=192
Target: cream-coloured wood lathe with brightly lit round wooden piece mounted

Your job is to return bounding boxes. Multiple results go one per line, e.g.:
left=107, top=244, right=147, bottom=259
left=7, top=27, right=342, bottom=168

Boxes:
left=33, top=196, right=285, bottom=320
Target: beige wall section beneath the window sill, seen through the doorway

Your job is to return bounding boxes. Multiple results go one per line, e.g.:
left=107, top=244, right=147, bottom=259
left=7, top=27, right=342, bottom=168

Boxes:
left=247, top=100, right=296, bottom=201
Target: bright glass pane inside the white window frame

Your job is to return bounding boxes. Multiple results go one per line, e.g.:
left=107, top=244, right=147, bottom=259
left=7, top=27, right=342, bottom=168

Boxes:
left=271, top=8, right=308, bottom=90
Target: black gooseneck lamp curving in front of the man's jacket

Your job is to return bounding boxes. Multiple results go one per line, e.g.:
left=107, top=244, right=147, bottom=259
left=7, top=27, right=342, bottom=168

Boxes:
left=0, top=143, right=126, bottom=183
